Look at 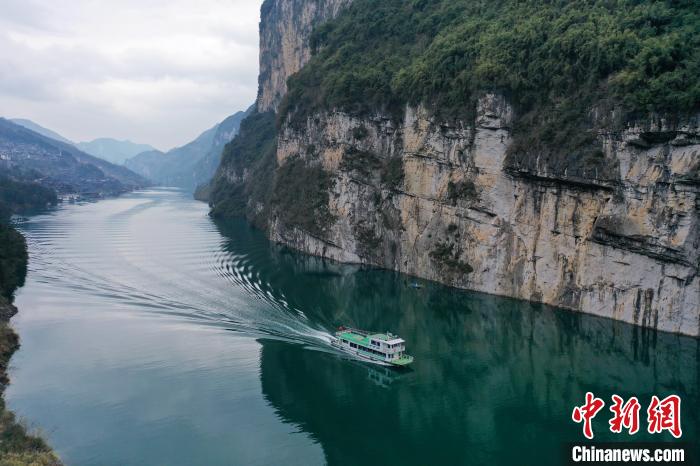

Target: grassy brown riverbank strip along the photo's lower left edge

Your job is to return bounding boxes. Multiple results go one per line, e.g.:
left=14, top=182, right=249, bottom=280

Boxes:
left=0, top=225, right=61, bottom=466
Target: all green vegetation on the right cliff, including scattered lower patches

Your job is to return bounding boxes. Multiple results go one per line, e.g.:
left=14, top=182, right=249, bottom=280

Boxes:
left=210, top=0, right=700, bottom=255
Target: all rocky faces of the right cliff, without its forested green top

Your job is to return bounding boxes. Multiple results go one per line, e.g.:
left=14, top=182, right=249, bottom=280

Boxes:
left=211, top=0, right=700, bottom=336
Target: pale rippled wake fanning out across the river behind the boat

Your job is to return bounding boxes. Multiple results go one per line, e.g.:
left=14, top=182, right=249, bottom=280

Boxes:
left=18, top=190, right=334, bottom=351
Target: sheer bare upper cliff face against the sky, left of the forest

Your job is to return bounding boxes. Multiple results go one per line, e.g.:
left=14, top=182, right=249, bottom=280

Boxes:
left=257, top=0, right=352, bottom=113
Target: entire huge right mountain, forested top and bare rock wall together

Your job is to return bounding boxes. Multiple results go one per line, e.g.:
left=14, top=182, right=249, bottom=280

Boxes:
left=209, top=0, right=700, bottom=336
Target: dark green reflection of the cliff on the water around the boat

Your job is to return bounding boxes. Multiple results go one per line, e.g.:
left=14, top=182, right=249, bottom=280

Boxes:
left=218, top=222, right=700, bottom=464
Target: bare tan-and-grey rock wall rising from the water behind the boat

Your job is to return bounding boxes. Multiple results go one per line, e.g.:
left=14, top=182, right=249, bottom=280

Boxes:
left=270, top=100, right=700, bottom=336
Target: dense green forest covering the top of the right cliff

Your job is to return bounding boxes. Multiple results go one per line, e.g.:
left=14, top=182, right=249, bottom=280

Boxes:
left=280, top=0, right=700, bottom=173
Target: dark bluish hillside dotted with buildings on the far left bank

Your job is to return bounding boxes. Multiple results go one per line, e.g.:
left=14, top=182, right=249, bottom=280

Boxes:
left=0, top=118, right=148, bottom=196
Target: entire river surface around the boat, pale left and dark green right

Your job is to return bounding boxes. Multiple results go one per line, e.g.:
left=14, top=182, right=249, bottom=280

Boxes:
left=8, top=190, right=700, bottom=465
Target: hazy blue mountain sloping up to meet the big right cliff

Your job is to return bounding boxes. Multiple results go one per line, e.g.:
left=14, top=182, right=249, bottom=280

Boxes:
left=125, top=107, right=252, bottom=191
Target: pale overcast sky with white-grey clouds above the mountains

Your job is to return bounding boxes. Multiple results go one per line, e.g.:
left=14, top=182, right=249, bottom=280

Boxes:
left=0, top=0, right=262, bottom=149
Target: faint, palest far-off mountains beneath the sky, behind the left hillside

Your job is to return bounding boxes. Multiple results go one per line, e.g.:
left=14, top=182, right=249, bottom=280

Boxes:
left=10, top=118, right=155, bottom=165
